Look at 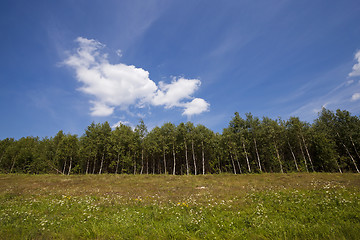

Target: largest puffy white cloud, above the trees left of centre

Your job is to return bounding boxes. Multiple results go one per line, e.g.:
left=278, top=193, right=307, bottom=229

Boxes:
left=64, top=37, right=209, bottom=116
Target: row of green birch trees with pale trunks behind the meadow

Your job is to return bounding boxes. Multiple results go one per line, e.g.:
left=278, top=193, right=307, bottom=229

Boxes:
left=0, top=108, right=360, bottom=175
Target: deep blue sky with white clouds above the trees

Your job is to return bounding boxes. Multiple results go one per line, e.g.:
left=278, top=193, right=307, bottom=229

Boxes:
left=0, top=0, right=360, bottom=139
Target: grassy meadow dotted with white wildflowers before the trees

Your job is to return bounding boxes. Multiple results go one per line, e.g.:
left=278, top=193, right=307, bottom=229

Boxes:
left=0, top=173, right=360, bottom=239
